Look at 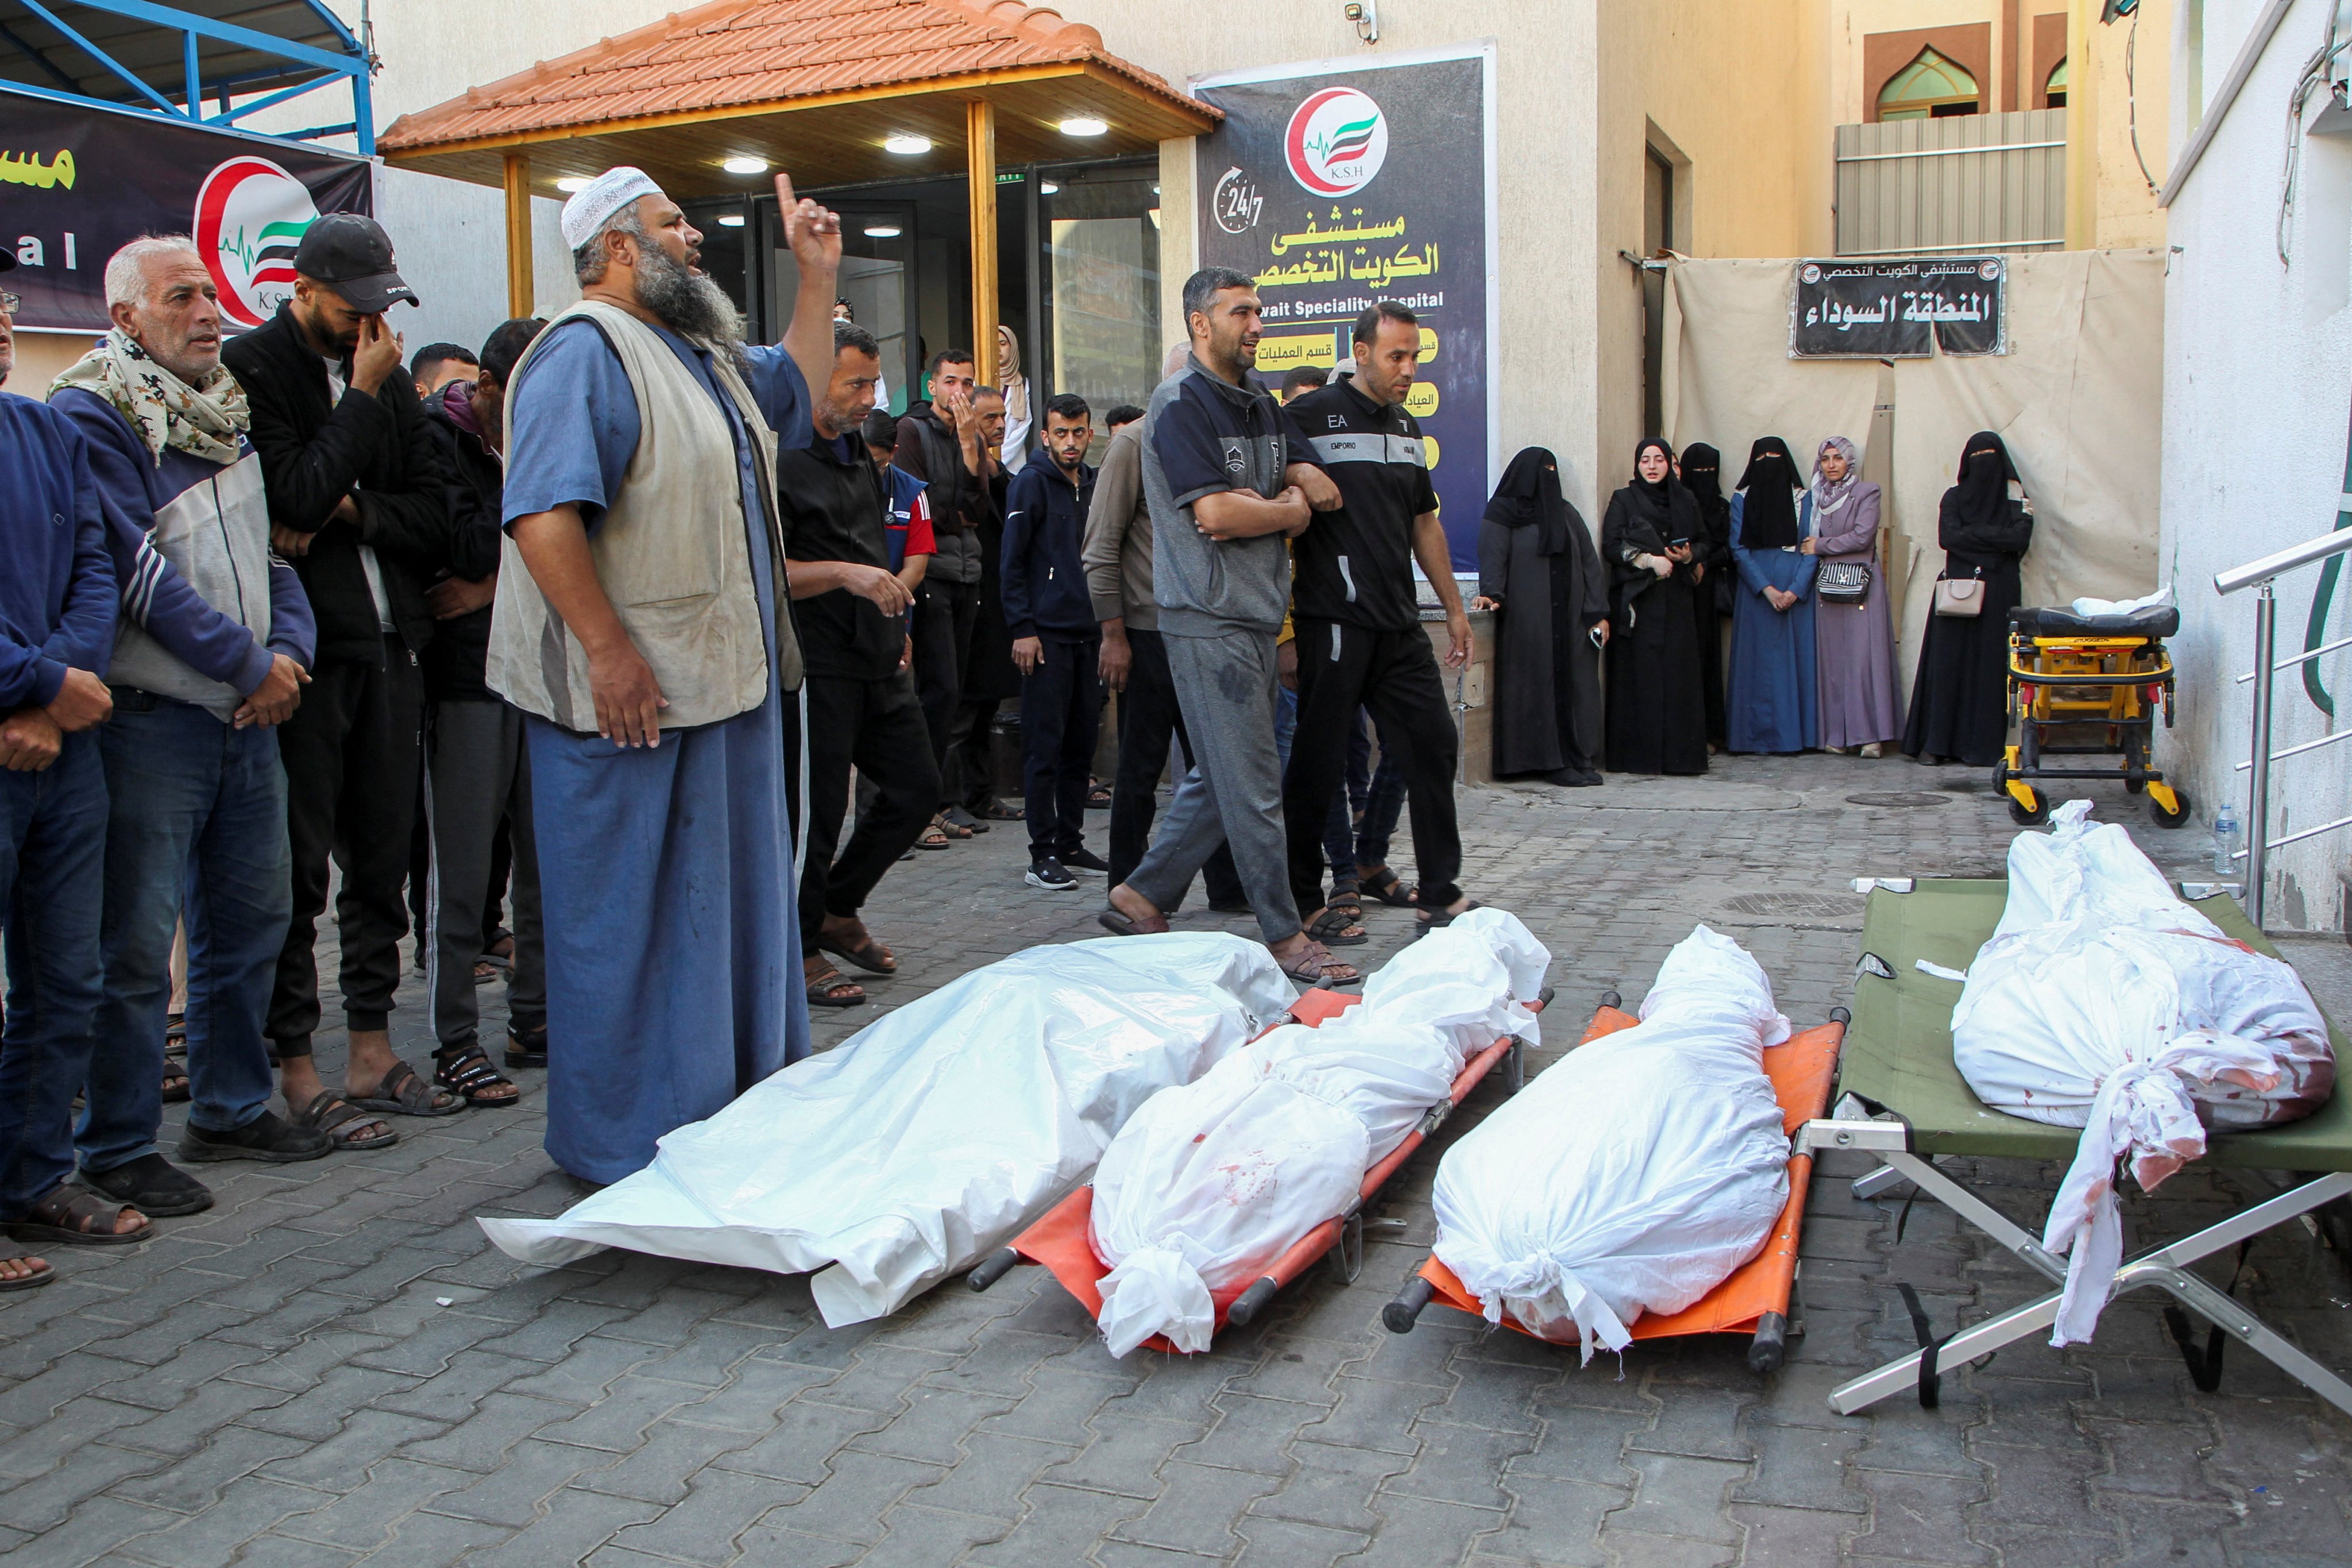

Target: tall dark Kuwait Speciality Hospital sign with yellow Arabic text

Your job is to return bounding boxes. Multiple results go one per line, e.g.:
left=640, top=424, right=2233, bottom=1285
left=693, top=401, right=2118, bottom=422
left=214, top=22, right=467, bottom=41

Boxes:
left=1190, top=45, right=1501, bottom=571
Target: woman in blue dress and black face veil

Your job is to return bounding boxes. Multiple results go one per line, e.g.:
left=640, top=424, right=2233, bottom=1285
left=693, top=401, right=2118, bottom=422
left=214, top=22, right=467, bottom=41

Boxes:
left=1724, top=435, right=1821, bottom=752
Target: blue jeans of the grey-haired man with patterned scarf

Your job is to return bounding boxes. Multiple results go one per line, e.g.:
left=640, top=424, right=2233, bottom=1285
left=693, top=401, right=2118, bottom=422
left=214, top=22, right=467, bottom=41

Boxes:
left=75, top=686, right=299, bottom=1171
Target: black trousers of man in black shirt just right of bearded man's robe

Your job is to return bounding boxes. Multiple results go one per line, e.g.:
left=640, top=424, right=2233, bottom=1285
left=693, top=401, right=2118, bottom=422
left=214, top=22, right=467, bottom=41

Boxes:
left=800, top=670, right=939, bottom=957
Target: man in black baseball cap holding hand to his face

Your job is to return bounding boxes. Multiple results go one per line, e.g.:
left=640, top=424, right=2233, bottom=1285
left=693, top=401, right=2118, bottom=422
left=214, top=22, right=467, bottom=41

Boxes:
left=221, top=211, right=473, bottom=1147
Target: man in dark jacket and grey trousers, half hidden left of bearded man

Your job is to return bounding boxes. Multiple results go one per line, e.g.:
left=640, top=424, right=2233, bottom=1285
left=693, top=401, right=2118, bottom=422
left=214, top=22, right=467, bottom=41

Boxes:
left=419, top=318, right=548, bottom=1105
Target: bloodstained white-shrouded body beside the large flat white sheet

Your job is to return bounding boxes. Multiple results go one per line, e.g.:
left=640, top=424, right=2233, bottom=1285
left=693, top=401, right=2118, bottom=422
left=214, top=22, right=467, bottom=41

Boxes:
left=1089, top=910, right=1552, bottom=1357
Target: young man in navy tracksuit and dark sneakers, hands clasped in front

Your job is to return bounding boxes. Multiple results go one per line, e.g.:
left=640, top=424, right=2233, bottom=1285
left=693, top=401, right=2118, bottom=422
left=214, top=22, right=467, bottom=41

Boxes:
left=1002, top=393, right=1110, bottom=893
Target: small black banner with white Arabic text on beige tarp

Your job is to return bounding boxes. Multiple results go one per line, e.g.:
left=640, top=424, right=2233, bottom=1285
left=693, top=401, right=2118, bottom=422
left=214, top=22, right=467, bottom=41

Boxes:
left=1787, top=256, right=2009, bottom=360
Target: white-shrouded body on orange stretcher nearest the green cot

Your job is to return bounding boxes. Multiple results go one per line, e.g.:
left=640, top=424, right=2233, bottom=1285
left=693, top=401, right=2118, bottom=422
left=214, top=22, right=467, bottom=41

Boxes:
left=1435, top=926, right=1790, bottom=1361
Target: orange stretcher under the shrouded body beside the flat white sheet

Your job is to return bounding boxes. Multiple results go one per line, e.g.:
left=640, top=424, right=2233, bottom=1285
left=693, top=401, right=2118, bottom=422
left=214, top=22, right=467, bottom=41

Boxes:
left=964, top=987, right=1552, bottom=1354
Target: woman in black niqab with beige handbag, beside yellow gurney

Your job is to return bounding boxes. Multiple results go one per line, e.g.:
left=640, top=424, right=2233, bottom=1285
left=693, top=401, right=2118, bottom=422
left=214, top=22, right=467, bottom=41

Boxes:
left=1903, top=430, right=2034, bottom=768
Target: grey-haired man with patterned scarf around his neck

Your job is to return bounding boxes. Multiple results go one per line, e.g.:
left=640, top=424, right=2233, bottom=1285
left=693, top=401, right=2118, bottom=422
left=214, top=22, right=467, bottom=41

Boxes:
left=49, top=237, right=329, bottom=1215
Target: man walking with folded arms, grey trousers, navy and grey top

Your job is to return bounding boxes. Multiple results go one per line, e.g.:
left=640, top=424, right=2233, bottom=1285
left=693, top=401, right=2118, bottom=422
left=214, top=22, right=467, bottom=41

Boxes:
left=1100, top=268, right=1362, bottom=985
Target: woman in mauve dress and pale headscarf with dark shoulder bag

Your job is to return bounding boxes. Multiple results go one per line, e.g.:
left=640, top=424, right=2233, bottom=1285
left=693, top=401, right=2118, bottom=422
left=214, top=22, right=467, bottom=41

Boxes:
left=1797, top=435, right=1903, bottom=757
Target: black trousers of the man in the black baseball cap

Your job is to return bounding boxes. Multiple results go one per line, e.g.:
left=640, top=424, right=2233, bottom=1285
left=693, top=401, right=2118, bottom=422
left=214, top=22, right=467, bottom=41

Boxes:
left=266, top=635, right=426, bottom=1056
